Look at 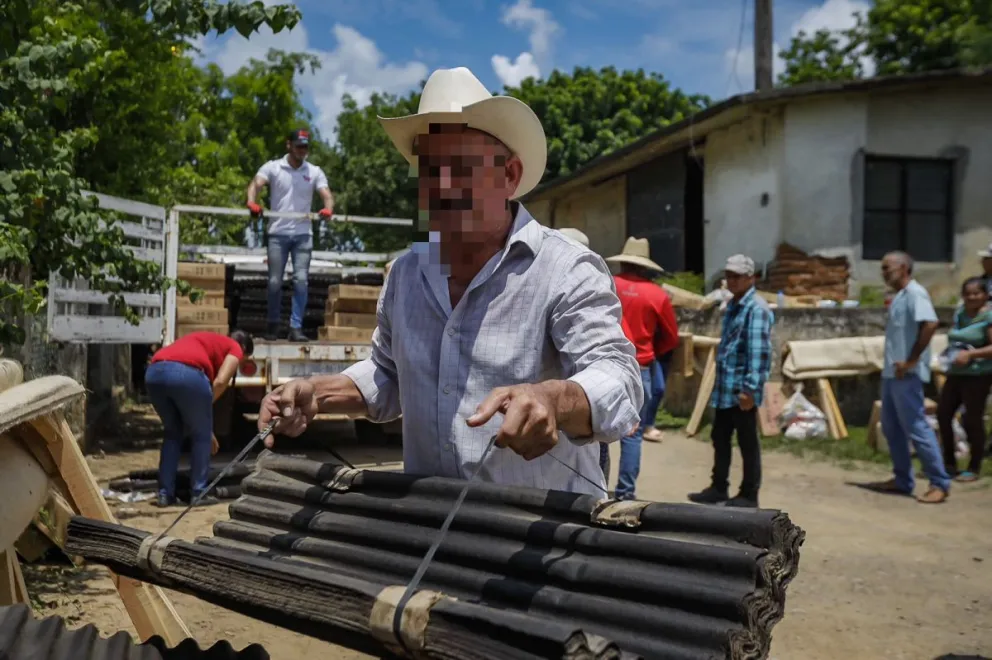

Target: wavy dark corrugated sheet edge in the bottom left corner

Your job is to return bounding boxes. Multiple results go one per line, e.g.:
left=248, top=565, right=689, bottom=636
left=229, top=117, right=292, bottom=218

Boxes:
left=0, top=605, right=269, bottom=660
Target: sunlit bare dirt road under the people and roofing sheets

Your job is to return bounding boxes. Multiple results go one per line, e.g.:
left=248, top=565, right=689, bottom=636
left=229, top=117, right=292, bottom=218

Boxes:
left=28, top=433, right=992, bottom=660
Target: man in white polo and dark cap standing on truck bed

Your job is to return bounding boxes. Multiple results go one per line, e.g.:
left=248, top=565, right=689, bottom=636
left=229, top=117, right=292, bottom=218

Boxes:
left=248, top=129, right=334, bottom=341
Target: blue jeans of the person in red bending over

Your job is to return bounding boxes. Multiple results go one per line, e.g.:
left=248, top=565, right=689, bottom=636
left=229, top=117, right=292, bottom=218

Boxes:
left=145, top=362, right=214, bottom=499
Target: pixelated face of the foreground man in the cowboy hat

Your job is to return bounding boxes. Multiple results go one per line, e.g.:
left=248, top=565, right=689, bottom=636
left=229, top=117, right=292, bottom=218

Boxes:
left=414, top=124, right=523, bottom=246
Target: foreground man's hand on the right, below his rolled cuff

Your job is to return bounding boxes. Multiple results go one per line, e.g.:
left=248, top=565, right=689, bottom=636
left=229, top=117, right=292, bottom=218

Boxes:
left=468, top=385, right=558, bottom=461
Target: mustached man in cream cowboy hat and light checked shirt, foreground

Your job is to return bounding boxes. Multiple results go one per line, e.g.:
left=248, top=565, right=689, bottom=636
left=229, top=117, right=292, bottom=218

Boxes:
left=259, top=68, right=643, bottom=496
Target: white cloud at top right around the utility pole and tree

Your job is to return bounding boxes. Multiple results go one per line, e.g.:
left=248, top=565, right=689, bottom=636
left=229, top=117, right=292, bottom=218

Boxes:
left=725, top=0, right=873, bottom=92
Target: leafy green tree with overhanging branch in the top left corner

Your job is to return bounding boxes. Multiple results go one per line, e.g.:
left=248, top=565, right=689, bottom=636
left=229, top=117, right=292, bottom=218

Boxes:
left=0, top=0, right=300, bottom=343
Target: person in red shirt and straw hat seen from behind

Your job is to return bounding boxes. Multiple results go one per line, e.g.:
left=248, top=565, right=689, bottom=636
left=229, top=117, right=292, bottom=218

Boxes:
left=600, top=238, right=679, bottom=500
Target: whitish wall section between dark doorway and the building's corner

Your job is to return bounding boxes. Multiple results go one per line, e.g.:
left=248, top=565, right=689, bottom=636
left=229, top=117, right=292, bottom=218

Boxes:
left=703, top=114, right=784, bottom=282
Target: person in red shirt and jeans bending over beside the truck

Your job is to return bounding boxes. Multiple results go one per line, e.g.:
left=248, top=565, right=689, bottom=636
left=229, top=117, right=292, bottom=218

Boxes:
left=145, top=330, right=255, bottom=506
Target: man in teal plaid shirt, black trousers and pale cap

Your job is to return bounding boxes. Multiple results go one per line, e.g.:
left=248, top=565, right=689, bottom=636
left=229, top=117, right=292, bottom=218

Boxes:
left=689, top=254, right=775, bottom=508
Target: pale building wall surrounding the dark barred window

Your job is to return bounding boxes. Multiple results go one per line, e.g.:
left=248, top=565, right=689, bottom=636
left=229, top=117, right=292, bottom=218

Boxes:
left=781, top=88, right=992, bottom=302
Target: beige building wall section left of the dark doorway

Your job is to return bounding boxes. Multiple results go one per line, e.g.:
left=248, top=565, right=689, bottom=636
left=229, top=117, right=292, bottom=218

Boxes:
left=528, top=176, right=627, bottom=257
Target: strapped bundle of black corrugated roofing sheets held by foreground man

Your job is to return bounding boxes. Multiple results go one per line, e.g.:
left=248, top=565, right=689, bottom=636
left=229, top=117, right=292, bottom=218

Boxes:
left=68, top=452, right=804, bottom=660
